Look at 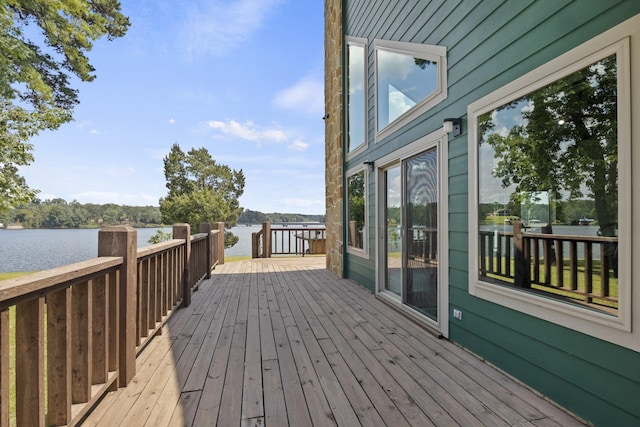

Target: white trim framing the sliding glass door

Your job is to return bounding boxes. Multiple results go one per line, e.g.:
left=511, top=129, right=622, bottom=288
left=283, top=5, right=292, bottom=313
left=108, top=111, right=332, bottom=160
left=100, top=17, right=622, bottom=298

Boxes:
left=375, top=127, right=449, bottom=338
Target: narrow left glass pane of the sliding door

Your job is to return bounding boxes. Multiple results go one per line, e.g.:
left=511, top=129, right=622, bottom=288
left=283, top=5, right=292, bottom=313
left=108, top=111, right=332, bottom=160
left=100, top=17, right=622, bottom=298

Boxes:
left=384, top=166, right=402, bottom=296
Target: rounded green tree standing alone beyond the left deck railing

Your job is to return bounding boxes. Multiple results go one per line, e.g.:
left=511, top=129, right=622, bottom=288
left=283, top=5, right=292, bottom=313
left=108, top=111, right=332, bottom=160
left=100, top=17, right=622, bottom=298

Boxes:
left=160, top=144, right=245, bottom=248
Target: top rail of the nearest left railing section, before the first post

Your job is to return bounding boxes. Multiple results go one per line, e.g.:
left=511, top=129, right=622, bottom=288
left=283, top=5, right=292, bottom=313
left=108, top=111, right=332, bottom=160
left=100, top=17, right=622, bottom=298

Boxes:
left=0, top=257, right=123, bottom=309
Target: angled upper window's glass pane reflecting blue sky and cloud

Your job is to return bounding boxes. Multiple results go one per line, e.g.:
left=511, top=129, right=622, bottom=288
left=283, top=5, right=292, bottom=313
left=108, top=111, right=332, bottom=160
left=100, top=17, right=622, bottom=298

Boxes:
left=376, top=49, right=438, bottom=130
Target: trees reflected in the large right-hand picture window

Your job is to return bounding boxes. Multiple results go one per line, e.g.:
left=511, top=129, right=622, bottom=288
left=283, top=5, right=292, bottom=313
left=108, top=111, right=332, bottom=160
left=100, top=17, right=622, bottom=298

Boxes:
left=478, top=55, right=618, bottom=236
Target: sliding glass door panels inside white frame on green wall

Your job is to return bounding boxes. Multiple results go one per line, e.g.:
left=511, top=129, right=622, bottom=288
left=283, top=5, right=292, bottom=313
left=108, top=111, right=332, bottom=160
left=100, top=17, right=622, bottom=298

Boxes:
left=380, top=146, right=441, bottom=322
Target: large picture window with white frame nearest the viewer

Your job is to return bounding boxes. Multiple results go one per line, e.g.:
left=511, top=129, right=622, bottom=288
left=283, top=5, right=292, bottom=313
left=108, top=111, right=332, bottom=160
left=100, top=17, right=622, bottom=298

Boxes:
left=468, top=30, right=631, bottom=352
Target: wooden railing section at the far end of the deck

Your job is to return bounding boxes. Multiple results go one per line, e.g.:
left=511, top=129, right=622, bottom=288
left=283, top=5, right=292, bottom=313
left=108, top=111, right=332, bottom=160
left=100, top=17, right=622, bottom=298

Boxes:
left=251, top=222, right=326, bottom=258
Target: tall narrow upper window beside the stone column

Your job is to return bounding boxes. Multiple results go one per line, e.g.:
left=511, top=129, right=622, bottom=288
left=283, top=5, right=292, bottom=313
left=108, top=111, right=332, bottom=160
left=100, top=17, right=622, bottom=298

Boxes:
left=345, top=37, right=367, bottom=153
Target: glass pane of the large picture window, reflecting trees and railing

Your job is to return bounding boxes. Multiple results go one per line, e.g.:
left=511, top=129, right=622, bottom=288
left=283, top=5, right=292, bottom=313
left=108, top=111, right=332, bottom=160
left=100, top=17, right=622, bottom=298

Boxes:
left=478, top=55, right=618, bottom=314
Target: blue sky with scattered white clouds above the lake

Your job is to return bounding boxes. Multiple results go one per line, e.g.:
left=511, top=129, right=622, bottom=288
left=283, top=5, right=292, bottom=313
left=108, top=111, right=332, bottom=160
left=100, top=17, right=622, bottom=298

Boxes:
left=22, top=0, right=325, bottom=214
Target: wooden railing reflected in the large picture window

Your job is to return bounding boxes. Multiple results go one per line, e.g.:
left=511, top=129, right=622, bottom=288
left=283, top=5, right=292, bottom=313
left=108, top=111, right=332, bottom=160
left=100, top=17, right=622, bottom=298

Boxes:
left=478, top=222, right=618, bottom=312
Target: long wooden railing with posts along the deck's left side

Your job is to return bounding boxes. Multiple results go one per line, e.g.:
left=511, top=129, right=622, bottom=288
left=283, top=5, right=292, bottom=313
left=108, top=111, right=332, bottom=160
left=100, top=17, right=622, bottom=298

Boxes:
left=0, top=223, right=224, bottom=426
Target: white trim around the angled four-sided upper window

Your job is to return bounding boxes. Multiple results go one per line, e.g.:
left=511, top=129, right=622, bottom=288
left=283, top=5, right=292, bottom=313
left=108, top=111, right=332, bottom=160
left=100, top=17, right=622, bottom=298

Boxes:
left=373, top=39, right=447, bottom=143
